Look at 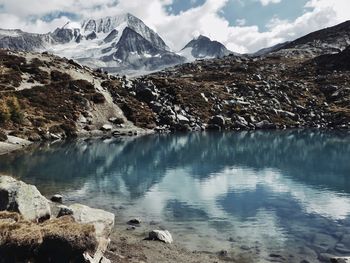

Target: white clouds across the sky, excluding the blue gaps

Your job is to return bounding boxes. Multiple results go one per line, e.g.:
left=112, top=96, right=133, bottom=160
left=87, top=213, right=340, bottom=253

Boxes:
left=0, top=0, right=350, bottom=53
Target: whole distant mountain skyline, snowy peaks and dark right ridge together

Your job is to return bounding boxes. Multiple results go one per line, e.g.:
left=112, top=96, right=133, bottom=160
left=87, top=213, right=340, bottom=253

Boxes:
left=0, top=14, right=350, bottom=75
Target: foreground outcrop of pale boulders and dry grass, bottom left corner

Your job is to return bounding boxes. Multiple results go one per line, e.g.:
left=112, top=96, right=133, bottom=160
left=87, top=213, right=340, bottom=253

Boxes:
left=0, top=175, right=114, bottom=263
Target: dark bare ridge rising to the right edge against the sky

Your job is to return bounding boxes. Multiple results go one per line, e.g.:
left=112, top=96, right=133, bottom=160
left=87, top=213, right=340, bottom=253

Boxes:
left=256, top=21, right=350, bottom=57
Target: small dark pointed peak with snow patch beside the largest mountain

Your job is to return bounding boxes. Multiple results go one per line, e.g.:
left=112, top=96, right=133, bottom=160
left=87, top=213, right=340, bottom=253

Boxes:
left=178, top=35, right=233, bottom=61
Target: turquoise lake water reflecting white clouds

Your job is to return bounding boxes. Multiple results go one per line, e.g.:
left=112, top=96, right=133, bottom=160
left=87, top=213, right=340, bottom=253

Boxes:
left=0, top=131, right=350, bottom=262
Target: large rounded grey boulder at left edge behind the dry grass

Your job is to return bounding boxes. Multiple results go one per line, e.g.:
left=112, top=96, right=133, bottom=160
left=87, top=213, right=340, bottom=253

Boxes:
left=0, top=175, right=51, bottom=222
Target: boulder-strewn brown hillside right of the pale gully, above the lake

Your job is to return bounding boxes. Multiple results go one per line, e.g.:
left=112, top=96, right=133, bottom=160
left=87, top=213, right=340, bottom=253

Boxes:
left=104, top=48, right=350, bottom=131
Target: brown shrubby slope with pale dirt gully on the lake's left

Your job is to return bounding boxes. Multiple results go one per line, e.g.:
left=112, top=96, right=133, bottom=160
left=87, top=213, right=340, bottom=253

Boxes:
left=0, top=50, right=144, bottom=144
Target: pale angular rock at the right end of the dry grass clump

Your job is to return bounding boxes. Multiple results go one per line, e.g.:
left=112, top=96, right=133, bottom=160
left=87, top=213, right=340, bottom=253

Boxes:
left=69, top=204, right=115, bottom=263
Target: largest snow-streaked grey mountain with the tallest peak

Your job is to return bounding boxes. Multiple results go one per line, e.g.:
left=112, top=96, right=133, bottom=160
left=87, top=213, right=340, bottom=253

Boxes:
left=0, top=14, right=185, bottom=72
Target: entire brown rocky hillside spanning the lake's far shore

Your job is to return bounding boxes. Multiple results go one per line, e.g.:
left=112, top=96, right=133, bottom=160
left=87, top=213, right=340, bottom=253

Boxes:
left=0, top=44, right=350, bottom=145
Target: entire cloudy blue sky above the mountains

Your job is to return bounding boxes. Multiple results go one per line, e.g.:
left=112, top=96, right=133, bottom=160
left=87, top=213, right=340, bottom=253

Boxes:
left=0, top=0, right=350, bottom=53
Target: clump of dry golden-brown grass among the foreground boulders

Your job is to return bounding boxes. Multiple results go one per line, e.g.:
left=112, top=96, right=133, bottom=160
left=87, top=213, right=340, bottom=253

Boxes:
left=0, top=212, right=97, bottom=262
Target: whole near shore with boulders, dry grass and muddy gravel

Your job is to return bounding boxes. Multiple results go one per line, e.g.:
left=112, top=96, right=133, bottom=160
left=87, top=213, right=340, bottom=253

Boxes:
left=0, top=175, right=232, bottom=263
